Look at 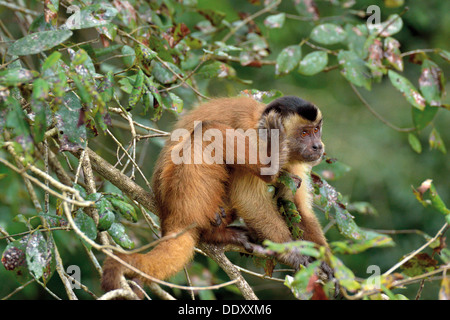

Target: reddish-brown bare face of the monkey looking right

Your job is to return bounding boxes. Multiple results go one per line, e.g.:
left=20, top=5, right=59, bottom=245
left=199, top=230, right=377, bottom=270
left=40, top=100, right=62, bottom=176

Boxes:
left=288, top=120, right=325, bottom=165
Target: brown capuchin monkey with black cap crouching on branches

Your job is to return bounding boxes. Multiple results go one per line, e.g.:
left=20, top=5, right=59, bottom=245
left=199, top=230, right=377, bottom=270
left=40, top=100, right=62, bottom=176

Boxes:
left=102, top=96, right=332, bottom=291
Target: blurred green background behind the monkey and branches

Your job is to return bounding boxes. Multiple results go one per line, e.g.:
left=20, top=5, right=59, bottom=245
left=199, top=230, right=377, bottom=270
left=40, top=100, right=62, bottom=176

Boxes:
left=0, top=0, right=450, bottom=299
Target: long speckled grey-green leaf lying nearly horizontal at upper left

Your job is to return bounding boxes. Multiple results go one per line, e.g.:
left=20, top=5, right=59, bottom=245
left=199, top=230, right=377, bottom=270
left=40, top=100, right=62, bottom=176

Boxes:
left=8, top=30, right=72, bottom=56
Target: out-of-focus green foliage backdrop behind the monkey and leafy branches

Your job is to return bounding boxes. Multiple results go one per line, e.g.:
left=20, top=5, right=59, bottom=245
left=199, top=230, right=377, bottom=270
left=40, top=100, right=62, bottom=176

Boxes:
left=0, top=0, right=450, bottom=299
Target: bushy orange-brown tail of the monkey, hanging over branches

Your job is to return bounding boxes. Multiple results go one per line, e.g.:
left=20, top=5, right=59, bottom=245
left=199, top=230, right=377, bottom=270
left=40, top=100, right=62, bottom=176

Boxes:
left=102, top=229, right=197, bottom=291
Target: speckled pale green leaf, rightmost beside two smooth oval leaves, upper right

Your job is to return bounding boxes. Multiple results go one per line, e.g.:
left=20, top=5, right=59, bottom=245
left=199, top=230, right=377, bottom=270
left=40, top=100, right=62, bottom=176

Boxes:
left=338, top=50, right=372, bottom=90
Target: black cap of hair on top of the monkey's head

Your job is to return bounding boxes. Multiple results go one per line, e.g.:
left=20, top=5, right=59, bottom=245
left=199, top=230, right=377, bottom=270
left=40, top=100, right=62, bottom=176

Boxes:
left=263, top=96, right=319, bottom=121
